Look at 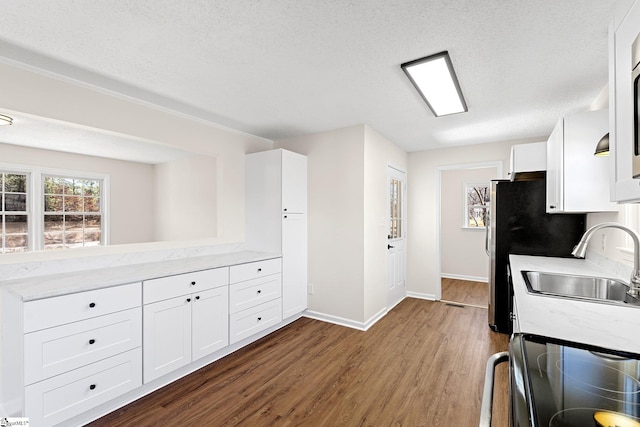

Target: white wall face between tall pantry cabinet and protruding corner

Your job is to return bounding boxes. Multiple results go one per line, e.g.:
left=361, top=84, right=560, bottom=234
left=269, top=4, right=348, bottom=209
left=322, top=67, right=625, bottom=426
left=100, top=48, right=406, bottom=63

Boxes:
left=275, top=126, right=364, bottom=322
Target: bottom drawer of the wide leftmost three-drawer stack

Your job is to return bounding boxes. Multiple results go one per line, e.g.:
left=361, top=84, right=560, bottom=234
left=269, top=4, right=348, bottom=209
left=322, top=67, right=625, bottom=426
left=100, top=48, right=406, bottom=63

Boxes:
left=25, top=348, right=142, bottom=426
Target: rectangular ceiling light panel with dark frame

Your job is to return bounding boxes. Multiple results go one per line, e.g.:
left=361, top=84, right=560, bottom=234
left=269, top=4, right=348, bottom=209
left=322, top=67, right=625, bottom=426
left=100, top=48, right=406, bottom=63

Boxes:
left=401, top=51, right=467, bottom=117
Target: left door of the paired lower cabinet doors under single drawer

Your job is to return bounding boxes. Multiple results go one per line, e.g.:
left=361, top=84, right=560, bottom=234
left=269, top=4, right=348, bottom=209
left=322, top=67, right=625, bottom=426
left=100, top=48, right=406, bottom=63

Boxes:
left=143, top=296, right=191, bottom=383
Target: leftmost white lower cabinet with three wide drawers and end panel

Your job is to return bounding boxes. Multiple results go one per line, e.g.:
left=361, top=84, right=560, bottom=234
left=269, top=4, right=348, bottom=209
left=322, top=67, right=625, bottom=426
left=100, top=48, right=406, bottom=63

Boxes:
left=0, top=283, right=142, bottom=427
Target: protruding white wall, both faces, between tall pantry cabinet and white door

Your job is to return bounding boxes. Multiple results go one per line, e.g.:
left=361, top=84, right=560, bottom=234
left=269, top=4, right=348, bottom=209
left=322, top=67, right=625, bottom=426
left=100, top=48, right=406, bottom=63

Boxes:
left=275, top=125, right=407, bottom=327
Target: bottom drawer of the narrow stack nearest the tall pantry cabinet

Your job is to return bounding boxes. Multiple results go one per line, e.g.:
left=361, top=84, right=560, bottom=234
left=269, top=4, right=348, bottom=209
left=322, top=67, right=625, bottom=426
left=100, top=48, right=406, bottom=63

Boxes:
left=229, top=299, right=282, bottom=344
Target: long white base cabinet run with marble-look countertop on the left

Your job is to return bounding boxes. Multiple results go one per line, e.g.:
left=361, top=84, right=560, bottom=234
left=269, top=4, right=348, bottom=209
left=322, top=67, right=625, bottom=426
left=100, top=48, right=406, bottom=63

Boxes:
left=0, top=244, right=308, bottom=426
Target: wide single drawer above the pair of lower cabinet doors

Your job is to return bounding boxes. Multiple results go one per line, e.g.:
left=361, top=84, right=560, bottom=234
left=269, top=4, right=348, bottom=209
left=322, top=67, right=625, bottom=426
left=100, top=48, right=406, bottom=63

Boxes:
left=143, top=267, right=229, bottom=304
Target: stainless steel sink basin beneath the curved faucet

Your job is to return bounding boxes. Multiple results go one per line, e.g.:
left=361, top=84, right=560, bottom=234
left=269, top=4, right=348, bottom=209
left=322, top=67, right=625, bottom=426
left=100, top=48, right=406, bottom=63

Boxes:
left=522, top=271, right=640, bottom=306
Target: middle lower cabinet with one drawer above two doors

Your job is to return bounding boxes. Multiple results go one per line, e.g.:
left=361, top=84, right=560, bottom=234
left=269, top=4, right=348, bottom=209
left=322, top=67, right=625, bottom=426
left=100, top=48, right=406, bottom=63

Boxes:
left=143, top=267, right=229, bottom=383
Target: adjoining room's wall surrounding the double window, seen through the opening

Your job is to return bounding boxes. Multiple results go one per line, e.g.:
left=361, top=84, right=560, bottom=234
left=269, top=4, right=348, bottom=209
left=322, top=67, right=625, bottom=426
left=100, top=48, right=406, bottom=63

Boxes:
left=0, top=143, right=155, bottom=246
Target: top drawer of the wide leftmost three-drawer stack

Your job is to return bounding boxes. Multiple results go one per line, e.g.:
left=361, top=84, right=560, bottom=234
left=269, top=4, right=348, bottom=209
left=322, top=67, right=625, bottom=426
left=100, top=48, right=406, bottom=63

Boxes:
left=24, top=283, right=141, bottom=333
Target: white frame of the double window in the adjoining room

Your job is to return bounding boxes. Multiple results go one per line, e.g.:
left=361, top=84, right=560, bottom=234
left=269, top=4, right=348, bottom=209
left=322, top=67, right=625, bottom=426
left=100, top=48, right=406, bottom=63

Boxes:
left=0, top=162, right=110, bottom=251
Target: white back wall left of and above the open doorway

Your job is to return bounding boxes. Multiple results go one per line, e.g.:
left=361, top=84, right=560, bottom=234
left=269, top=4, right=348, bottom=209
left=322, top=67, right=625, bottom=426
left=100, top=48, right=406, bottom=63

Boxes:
left=407, top=138, right=528, bottom=299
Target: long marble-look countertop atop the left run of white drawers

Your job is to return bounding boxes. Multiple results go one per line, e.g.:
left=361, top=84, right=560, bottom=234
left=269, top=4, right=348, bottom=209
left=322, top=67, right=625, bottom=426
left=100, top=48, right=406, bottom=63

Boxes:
left=0, top=251, right=281, bottom=301
